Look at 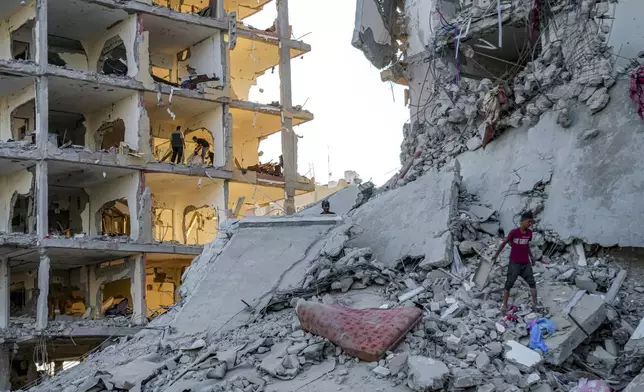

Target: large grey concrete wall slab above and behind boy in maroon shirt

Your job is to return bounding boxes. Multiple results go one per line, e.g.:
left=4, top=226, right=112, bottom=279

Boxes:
left=458, top=80, right=644, bottom=246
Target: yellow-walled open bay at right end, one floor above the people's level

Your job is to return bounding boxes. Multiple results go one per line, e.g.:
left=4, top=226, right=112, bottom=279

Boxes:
left=228, top=32, right=311, bottom=101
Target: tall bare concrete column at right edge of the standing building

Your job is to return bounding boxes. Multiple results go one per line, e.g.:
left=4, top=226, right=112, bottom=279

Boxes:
left=277, top=0, right=297, bottom=215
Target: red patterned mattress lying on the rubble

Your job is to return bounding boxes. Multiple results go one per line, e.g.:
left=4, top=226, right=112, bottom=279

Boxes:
left=295, top=301, right=422, bottom=362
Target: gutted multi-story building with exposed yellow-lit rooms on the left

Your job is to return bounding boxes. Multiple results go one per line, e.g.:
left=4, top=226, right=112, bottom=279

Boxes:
left=0, top=0, right=314, bottom=390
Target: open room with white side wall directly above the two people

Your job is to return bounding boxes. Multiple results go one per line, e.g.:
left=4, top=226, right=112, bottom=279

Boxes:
left=139, top=9, right=228, bottom=100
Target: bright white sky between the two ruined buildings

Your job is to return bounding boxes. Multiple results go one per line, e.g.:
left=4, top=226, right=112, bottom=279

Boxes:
left=244, top=0, right=409, bottom=185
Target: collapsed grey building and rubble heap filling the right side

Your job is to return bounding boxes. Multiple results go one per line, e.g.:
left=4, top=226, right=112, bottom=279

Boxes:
left=3, top=0, right=644, bottom=392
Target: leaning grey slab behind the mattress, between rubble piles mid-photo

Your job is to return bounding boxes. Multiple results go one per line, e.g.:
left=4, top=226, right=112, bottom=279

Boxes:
left=349, top=164, right=460, bottom=269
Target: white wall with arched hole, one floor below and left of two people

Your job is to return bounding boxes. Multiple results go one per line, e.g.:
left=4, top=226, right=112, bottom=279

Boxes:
left=83, top=172, right=141, bottom=240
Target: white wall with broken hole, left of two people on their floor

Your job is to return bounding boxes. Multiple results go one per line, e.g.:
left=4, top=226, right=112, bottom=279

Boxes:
left=83, top=92, right=142, bottom=151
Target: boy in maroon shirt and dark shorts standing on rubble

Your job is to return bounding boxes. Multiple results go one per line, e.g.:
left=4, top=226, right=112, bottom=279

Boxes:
left=492, top=212, right=537, bottom=313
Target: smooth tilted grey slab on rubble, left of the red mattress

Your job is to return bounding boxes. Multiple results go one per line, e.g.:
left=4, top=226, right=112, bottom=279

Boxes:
left=173, top=224, right=333, bottom=335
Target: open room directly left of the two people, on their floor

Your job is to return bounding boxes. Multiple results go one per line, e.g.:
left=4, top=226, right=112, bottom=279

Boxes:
left=48, top=77, right=149, bottom=165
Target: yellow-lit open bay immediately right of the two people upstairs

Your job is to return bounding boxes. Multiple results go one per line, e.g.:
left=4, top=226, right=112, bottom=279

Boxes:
left=230, top=101, right=315, bottom=191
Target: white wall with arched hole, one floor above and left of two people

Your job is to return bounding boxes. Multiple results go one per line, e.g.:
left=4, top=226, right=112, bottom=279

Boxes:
left=82, top=14, right=139, bottom=78
